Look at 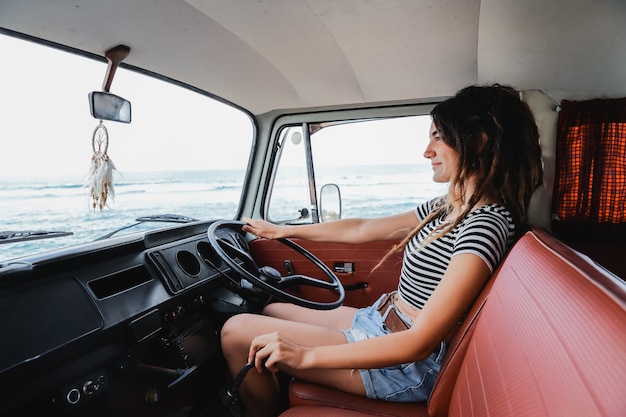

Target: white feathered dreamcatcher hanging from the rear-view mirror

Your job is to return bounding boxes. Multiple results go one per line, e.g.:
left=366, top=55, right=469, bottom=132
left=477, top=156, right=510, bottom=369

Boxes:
left=85, top=120, right=115, bottom=210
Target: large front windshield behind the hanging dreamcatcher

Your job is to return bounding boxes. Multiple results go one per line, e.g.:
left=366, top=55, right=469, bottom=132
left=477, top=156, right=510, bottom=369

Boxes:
left=0, top=34, right=253, bottom=262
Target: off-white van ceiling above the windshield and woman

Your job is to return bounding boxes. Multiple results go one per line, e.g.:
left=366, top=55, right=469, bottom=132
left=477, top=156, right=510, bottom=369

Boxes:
left=0, top=0, right=626, bottom=114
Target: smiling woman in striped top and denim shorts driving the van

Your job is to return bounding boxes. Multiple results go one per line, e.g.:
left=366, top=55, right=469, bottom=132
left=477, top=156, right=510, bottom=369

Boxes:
left=222, top=85, right=543, bottom=416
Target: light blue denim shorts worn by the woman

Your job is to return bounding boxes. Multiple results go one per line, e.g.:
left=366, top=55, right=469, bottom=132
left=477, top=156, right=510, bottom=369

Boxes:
left=343, top=295, right=448, bottom=402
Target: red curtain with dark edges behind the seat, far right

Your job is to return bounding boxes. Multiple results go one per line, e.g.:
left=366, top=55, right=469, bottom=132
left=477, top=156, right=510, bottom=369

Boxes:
left=552, top=98, right=626, bottom=239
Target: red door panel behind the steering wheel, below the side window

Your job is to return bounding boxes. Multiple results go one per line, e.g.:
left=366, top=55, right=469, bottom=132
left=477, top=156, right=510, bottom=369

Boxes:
left=250, top=239, right=402, bottom=307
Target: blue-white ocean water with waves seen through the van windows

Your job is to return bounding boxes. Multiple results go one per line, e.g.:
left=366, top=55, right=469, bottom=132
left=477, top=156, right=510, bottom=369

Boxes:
left=0, top=165, right=445, bottom=262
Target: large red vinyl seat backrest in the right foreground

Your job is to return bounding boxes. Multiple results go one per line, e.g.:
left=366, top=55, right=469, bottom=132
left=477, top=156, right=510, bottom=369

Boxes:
left=438, top=230, right=626, bottom=417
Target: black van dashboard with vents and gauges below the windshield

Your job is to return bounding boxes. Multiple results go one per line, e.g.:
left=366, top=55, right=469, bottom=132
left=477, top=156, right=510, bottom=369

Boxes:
left=0, top=222, right=260, bottom=415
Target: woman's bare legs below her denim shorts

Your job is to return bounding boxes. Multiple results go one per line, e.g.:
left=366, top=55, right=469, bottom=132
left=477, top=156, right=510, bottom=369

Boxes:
left=221, top=304, right=365, bottom=416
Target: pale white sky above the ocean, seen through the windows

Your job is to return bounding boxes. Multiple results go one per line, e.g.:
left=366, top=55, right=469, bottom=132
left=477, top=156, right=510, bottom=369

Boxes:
left=0, top=35, right=430, bottom=178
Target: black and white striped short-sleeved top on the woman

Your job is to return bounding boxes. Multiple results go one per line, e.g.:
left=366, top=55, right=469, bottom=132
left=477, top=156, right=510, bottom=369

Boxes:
left=398, top=198, right=515, bottom=310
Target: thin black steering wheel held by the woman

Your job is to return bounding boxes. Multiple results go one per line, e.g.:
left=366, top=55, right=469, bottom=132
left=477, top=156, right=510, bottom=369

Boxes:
left=207, top=220, right=346, bottom=310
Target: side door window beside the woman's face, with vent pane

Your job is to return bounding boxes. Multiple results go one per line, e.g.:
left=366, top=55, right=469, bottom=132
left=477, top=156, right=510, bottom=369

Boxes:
left=268, top=115, right=446, bottom=223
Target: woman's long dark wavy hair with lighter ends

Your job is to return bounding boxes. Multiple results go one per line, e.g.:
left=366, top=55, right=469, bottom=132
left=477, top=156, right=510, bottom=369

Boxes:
left=379, top=84, right=543, bottom=265
